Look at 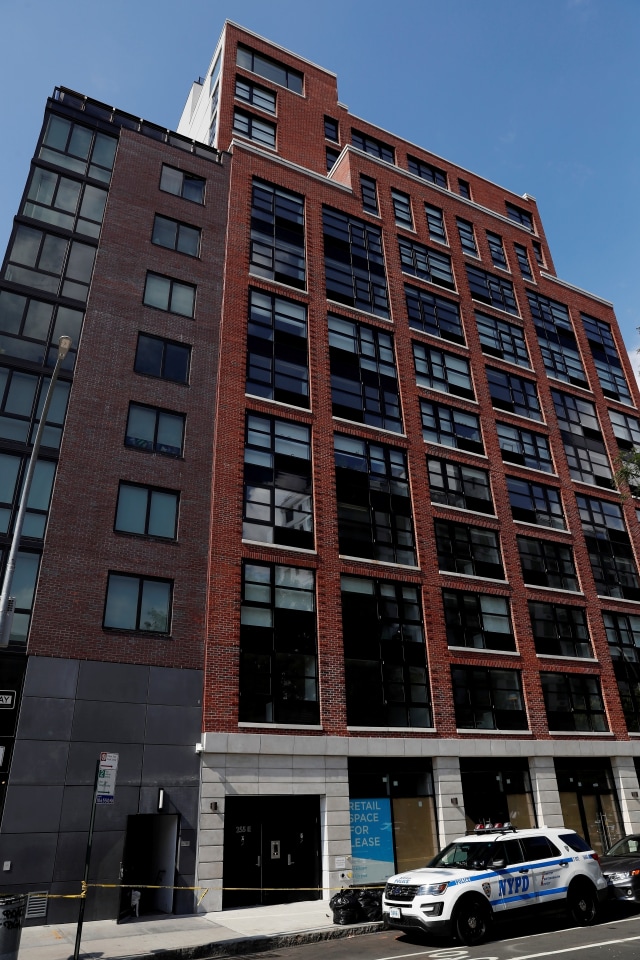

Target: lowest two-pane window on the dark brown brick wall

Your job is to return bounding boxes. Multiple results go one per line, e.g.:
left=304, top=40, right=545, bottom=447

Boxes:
left=102, top=573, right=173, bottom=633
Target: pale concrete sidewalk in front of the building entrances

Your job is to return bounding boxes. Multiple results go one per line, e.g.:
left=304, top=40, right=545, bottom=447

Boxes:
left=19, top=900, right=382, bottom=960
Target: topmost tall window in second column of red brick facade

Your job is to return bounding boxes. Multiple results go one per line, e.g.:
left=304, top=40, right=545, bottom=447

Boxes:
left=322, top=207, right=389, bottom=317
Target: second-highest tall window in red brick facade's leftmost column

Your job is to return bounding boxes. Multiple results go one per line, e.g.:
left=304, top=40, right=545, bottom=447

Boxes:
left=247, top=290, right=309, bottom=407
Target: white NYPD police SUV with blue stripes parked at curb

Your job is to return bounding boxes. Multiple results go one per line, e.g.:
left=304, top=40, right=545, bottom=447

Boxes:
left=382, top=824, right=607, bottom=945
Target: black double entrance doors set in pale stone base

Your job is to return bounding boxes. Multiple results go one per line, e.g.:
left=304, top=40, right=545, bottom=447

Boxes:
left=222, top=797, right=322, bottom=908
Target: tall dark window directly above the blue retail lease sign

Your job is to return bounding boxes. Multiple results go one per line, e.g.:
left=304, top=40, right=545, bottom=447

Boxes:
left=341, top=577, right=433, bottom=727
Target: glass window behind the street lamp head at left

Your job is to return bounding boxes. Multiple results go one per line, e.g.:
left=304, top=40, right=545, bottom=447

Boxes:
left=0, top=290, right=84, bottom=370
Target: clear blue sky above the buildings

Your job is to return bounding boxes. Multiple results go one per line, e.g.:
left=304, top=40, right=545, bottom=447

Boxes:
left=0, top=0, right=640, bottom=368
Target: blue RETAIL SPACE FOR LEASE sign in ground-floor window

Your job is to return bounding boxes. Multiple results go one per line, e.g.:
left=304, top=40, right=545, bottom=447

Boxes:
left=349, top=797, right=395, bottom=883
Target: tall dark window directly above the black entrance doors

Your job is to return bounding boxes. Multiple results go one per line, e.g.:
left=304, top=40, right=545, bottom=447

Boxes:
left=239, top=562, right=320, bottom=724
